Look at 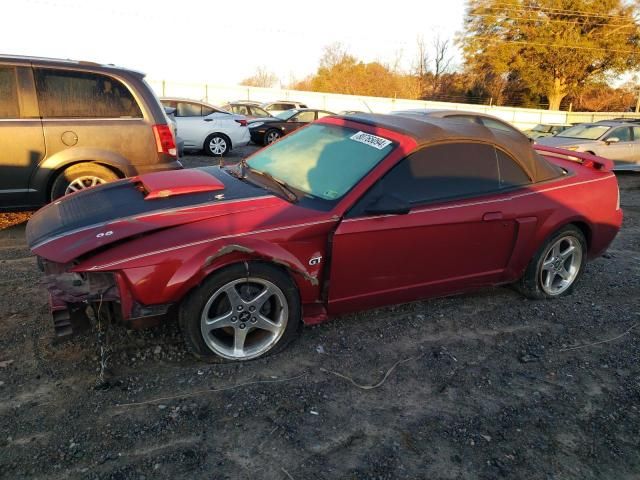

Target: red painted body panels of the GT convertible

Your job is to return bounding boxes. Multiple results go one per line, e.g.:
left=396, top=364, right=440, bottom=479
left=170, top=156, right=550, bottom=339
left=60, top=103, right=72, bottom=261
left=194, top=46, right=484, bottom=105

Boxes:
left=28, top=118, right=622, bottom=323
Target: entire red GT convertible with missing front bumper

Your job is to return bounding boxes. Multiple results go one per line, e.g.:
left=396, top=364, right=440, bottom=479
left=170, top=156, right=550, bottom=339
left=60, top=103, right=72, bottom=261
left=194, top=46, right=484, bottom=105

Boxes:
left=27, top=114, right=622, bottom=360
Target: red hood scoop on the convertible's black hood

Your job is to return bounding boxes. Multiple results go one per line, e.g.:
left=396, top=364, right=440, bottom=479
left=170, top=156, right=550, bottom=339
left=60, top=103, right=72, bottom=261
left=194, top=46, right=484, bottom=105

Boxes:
left=141, top=169, right=224, bottom=200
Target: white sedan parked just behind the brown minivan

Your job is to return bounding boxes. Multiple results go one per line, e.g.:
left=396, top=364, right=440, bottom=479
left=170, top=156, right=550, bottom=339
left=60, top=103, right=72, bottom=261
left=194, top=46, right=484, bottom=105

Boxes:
left=160, top=97, right=251, bottom=157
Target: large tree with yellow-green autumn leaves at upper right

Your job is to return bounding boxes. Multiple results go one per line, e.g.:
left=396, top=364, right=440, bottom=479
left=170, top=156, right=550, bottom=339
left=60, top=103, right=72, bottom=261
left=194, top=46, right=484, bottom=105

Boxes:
left=459, top=0, right=640, bottom=110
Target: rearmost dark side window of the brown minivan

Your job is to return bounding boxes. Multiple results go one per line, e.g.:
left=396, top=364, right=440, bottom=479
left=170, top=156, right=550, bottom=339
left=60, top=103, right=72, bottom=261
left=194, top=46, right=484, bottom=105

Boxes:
left=34, top=68, right=142, bottom=118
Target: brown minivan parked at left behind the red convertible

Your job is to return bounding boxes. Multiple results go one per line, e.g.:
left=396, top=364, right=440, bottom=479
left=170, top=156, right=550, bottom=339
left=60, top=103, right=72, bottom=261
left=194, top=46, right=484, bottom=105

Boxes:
left=0, top=55, right=181, bottom=210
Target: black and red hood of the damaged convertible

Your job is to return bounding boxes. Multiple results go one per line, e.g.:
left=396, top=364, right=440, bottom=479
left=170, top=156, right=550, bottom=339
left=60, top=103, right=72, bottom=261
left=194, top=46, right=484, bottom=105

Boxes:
left=26, top=167, right=290, bottom=263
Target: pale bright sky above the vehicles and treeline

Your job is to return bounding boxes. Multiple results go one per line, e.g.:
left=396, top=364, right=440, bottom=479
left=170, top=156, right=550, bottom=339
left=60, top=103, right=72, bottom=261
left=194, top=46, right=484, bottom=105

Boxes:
left=0, top=0, right=465, bottom=85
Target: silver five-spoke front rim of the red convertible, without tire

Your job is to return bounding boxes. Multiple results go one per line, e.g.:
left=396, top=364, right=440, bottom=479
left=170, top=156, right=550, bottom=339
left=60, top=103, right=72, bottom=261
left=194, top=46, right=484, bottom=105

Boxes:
left=200, top=277, right=289, bottom=360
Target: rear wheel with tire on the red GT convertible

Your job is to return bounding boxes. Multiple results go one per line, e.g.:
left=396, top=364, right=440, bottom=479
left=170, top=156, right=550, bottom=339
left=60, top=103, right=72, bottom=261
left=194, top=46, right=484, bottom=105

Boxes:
left=516, top=225, right=587, bottom=299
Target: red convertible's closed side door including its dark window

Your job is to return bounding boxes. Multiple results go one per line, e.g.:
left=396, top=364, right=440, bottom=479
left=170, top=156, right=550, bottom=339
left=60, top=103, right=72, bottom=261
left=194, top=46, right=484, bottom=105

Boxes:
left=329, top=143, right=530, bottom=314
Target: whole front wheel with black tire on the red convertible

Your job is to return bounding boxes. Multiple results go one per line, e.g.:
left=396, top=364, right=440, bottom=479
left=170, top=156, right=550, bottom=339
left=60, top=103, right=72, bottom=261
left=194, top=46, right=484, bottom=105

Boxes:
left=178, top=262, right=302, bottom=361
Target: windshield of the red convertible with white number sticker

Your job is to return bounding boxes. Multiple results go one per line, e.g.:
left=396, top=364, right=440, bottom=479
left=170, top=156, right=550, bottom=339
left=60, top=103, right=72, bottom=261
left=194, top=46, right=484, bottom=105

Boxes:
left=247, top=124, right=394, bottom=200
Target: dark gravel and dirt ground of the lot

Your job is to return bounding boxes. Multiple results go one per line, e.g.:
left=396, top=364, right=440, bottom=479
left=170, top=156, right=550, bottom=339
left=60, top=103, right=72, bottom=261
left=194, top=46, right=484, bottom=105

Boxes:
left=0, top=152, right=640, bottom=480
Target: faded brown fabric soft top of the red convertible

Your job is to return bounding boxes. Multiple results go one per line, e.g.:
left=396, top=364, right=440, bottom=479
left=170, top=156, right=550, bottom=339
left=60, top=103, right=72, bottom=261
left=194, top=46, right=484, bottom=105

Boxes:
left=343, top=113, right=562, bottom=182
